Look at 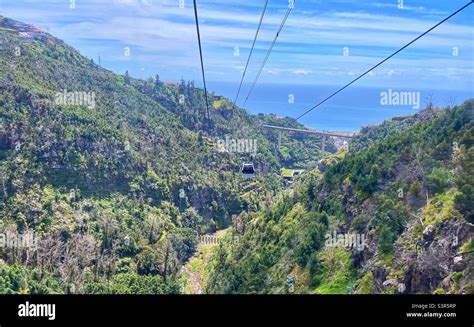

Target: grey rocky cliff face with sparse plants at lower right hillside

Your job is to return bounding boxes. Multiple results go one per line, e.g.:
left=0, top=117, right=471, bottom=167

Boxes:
left=386, top=217, right=474, bottom=294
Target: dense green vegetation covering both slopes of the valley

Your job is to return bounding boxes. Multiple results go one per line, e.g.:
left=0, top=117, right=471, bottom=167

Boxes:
left=0, top=17, right=474, bottom=294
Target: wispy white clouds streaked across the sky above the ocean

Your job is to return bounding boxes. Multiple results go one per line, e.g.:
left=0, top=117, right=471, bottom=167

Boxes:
left=0, top=0, right=474, bottom=89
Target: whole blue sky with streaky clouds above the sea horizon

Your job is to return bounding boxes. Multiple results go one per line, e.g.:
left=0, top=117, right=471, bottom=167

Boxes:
left=0, top=0, right=474, bottom=93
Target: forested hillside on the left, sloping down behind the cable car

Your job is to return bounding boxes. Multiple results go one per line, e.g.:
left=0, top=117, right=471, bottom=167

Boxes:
left=0, top=17, right=326, bottom=293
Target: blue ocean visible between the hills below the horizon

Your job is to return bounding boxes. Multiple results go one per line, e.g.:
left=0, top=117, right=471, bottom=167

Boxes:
left=208, top=82, right=474, bottom=131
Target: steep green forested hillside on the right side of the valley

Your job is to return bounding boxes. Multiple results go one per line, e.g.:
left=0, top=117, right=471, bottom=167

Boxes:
left=206, top=100, right=474, bottom=294
